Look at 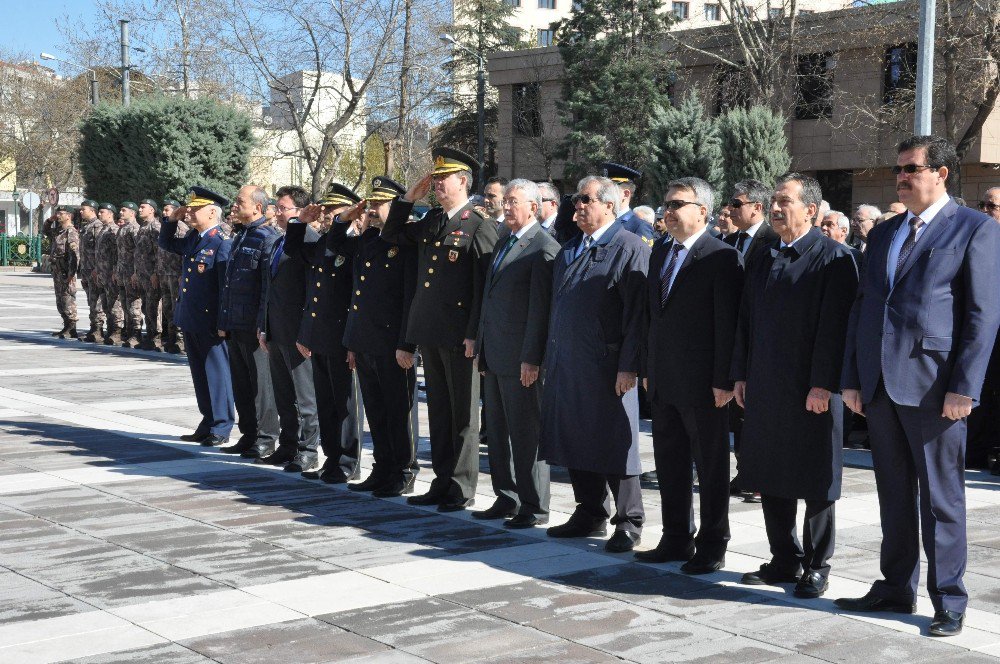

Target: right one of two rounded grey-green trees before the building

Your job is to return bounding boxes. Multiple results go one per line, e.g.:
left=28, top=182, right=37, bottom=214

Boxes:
left=717, top=106, right=792, bottom=196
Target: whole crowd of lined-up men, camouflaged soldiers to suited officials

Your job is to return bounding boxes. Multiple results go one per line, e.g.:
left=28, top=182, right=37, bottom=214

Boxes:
left=45, top=136, right=1000, bottom=636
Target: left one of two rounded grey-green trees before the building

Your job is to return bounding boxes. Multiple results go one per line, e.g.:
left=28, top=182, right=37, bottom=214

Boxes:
left=645, top=91, right=723, bottom=202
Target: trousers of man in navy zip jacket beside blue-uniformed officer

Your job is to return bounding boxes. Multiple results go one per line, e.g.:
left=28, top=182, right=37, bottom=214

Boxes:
left=227, top=330, right=278, bottom=452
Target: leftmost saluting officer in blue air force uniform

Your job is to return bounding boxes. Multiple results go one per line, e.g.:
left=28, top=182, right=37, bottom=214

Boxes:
left=158, top=187, right=234, bottom=447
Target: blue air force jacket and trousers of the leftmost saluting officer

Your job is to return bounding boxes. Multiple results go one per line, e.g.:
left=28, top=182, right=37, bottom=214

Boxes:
left=159, top=219, right=234, bottom=438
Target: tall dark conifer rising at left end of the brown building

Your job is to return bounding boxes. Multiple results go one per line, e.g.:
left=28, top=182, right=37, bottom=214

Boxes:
left=557, top=0, right=674, bottom=178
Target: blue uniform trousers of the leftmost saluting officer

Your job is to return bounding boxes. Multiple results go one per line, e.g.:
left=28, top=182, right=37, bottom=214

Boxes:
left=186, top=332, right=233, bottom=438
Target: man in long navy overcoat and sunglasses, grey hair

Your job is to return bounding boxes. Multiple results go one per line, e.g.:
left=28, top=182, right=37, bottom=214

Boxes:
left=540, top=176, right=649, bottom=553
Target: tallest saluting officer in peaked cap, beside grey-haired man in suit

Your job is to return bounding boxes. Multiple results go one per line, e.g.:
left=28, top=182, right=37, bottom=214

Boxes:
left=382, top=148, right=497, bottom=512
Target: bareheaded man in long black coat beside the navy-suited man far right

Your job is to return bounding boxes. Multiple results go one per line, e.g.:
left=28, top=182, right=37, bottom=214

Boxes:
left=732, top=173, right=858, bottom=598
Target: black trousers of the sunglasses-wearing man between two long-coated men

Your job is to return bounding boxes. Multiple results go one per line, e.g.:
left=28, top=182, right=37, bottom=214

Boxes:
left=652, top=402, right=729, bottom=560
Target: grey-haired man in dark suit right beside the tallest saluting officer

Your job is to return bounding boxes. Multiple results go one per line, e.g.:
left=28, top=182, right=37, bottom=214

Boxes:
left=472, top=180, right=559, bottom=528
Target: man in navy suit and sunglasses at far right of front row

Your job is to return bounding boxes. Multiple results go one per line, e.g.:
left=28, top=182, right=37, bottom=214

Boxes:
left=836, top=136, right=1000, bottom=636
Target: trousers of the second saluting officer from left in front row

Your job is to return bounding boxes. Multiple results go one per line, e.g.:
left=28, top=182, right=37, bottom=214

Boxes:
left=312, top=349, right=365, bottom=477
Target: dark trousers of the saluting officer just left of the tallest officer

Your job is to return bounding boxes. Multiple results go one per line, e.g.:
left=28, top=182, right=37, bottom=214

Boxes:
left=354, top=353, right=420, bottom=481
